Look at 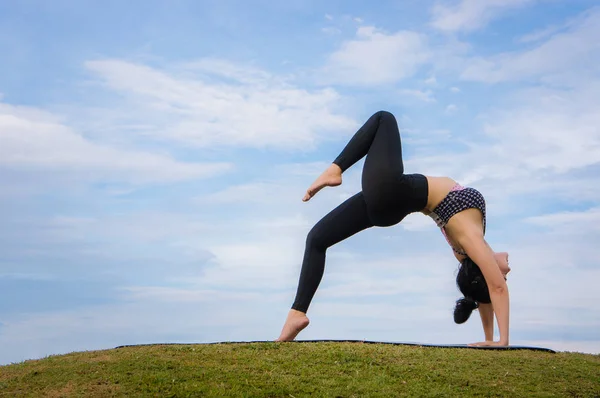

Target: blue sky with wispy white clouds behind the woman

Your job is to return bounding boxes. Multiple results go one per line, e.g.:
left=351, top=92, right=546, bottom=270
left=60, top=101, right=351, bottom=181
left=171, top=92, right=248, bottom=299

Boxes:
left=0, top=0, right=600, bottom=364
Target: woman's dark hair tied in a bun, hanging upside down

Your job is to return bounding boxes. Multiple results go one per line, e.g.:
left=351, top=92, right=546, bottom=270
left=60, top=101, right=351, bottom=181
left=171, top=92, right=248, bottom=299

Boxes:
left=454, top=257, right=492, bottom=323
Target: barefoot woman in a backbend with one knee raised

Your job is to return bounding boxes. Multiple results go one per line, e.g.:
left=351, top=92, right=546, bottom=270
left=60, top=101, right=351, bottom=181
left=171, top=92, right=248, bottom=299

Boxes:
left=277, top=111, right=510, bottom=346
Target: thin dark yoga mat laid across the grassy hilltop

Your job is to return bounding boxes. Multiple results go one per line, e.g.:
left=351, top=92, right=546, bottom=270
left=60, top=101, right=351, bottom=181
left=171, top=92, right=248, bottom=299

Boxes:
left=116, top=340, right=556, bottom=353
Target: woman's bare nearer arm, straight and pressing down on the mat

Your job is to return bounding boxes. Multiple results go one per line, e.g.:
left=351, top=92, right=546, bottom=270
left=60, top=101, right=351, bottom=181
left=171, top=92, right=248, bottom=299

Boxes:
left=459, top=232, right=510, bottom=345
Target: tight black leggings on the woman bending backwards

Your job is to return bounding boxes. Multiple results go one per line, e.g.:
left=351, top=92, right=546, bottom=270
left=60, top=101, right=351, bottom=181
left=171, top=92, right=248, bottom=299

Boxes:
left=292, top=111, right=428, bottom=312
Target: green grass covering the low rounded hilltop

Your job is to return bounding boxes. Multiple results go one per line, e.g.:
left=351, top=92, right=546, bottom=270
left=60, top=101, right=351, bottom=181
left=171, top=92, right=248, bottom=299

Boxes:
left=0, top=343, right=600, bottom=397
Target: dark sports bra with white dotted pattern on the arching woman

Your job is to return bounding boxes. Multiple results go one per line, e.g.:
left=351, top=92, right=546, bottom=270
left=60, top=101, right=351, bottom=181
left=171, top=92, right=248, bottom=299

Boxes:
left=429, top=184, right=486, bottom=256
